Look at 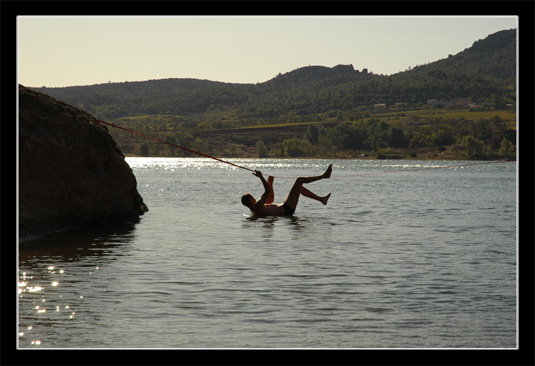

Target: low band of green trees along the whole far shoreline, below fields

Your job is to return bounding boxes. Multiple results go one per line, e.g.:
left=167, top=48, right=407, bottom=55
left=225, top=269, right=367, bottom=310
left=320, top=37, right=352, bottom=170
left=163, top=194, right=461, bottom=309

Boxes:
left=115, top=112, right=516, bottom=159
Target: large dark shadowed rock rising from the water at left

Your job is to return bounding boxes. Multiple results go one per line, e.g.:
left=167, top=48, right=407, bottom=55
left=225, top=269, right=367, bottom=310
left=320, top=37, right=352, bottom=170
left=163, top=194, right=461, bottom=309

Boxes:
left=18, top=85, right=147, bottom=241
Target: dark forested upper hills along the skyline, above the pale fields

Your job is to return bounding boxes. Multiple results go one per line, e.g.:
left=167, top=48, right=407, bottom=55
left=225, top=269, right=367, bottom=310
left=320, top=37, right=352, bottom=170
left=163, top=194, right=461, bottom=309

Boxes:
left=32, top=29, right=516, bottom=127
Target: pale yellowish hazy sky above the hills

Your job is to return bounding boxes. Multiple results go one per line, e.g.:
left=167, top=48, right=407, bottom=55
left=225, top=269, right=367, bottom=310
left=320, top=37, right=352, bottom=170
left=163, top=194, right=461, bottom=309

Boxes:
left=17, top=16, right=517, bottom=87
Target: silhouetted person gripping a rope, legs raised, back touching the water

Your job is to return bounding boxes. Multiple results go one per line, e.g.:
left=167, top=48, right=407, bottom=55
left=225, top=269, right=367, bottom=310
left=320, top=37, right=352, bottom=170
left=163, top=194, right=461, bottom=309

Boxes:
left=241, top=164, right=333, bottom=216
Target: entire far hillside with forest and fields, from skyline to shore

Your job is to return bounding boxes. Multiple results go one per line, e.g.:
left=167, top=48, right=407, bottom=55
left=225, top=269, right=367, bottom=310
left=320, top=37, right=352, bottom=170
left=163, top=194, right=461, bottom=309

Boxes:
left=31, top=29, right=516, bottom=159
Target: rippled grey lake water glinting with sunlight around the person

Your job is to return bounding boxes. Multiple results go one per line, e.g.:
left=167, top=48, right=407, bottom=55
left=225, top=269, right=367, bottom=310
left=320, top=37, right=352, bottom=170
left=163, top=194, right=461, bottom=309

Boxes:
left=18, top=158, right=517, bottom=349
